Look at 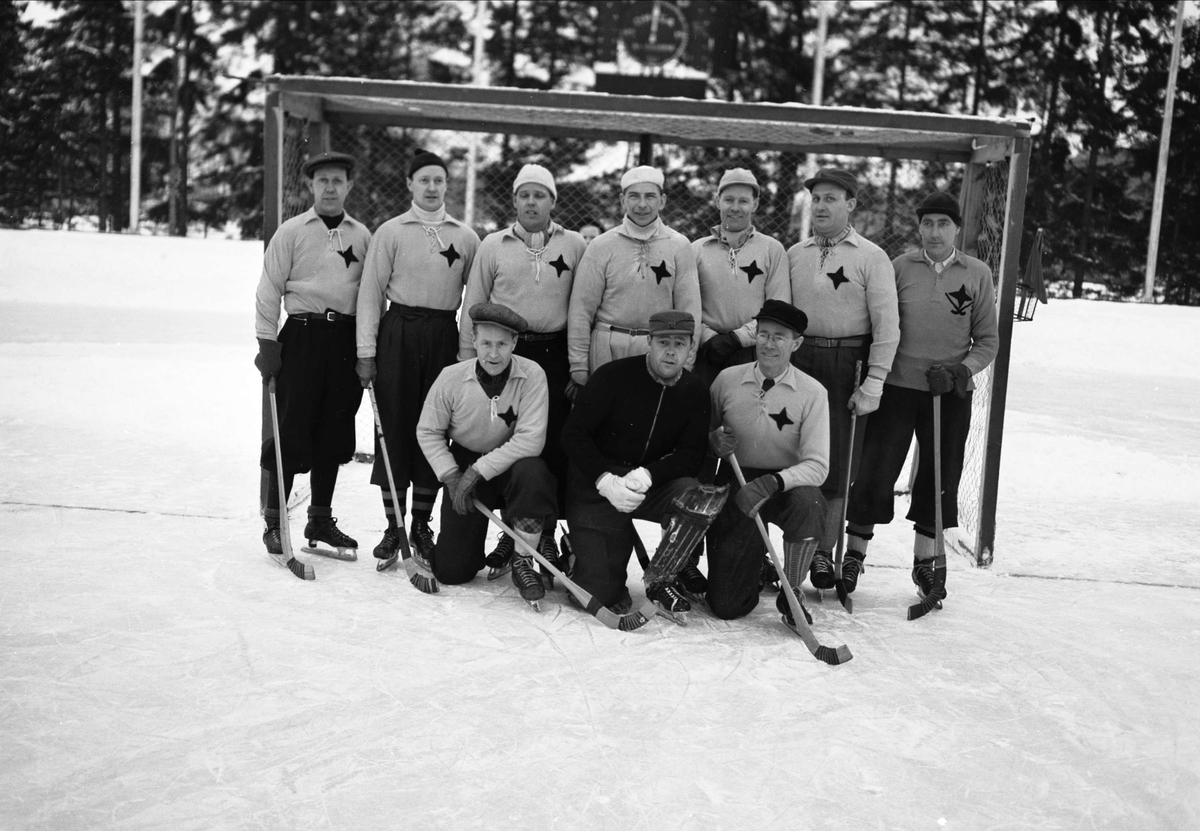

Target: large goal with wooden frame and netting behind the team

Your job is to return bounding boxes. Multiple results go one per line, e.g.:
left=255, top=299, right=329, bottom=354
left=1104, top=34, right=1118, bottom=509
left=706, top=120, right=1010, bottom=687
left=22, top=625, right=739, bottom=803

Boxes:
left=263, top=76, right=1030, bottom=567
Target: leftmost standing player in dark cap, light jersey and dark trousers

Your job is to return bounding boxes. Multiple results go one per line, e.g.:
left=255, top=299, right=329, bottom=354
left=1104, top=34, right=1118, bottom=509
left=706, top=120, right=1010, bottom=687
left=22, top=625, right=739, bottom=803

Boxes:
left=254, top=153, right=371, bottom=571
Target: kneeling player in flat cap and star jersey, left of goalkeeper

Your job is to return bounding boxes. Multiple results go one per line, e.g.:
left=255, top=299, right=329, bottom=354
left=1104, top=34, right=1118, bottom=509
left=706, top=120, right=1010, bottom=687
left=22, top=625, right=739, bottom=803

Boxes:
left=416, top=303, right=558, bottom=609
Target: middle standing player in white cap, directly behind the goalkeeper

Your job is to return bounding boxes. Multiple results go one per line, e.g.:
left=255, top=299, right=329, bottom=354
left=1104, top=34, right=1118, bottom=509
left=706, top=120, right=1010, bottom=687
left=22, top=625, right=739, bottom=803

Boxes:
left=566, top=165, right=701, bottom=387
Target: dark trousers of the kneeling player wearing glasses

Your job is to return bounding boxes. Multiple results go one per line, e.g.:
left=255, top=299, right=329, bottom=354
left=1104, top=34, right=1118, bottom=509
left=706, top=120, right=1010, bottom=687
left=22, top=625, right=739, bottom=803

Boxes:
left=707, top=466, right=827, bottom=621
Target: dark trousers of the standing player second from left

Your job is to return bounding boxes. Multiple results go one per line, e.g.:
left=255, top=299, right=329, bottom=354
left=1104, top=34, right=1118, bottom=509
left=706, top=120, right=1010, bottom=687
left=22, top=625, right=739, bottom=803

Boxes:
left=371, top=303, right=458, bottom=490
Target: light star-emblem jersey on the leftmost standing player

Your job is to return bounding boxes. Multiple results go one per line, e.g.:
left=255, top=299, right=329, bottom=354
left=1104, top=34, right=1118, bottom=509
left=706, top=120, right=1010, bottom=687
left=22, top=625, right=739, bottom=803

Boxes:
left=254, top=208, right=371, bottom=341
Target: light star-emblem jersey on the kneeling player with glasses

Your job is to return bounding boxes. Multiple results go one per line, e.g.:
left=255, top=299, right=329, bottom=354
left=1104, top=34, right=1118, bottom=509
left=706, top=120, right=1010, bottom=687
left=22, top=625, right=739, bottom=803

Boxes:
left=708, top=364, right=829, bottom=490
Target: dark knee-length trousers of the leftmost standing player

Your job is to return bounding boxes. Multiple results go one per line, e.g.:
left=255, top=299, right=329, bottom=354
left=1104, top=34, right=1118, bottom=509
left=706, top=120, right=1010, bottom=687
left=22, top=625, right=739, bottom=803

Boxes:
left=259, top=317, right=362, bottom=477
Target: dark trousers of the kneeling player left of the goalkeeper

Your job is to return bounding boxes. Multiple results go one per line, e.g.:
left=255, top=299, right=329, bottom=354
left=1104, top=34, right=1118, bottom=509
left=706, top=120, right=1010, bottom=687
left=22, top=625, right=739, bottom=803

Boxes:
left=433, top=444, right=558, bottom=585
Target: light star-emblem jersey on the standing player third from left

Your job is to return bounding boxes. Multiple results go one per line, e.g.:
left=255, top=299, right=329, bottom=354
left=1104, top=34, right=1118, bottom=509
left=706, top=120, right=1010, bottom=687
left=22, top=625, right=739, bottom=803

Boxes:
left=458, top=223, right=588, bottom=359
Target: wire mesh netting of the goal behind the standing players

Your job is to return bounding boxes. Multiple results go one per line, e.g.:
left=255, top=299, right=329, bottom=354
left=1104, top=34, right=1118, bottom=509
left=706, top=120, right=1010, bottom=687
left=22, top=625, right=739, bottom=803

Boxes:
left=282, top=116, right=1008, bottom=560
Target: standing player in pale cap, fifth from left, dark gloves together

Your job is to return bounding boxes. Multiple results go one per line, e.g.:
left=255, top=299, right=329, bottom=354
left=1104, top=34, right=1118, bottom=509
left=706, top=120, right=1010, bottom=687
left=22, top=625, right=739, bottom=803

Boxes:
left=691, top=167, right=792, bottom=383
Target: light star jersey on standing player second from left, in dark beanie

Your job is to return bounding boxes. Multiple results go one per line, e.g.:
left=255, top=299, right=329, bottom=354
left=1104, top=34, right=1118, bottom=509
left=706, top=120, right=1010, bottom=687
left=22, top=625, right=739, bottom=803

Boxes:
left=358, top=210, right=479, bottom=358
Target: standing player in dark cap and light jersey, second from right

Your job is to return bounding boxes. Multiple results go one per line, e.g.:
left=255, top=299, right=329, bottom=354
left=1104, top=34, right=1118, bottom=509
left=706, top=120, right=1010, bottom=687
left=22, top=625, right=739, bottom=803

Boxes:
left=787, top=168, right=900, bottom=588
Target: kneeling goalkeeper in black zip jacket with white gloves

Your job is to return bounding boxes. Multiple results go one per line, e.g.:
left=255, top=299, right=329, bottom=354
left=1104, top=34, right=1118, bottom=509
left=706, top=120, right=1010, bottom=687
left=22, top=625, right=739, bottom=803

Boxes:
left=563, top=307, right=727, bottom=620
